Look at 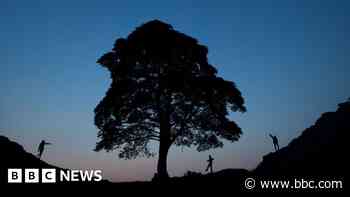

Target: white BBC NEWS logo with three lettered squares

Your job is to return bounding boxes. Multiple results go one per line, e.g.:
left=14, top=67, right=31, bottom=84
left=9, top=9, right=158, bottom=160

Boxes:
left=7, top=168, right=102, bottom=183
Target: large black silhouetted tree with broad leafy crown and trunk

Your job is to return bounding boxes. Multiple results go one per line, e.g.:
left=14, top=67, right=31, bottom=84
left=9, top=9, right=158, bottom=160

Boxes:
left=95, top=20, right=246, bottom=179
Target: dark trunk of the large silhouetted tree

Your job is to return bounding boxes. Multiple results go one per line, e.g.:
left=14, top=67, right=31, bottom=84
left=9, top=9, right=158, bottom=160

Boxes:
left=157, top=110, right=171, bottom=181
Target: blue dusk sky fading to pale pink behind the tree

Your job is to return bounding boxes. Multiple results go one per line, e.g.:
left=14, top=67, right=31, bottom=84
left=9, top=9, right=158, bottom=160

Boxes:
left=0, top=0, right=350, bottom=181
